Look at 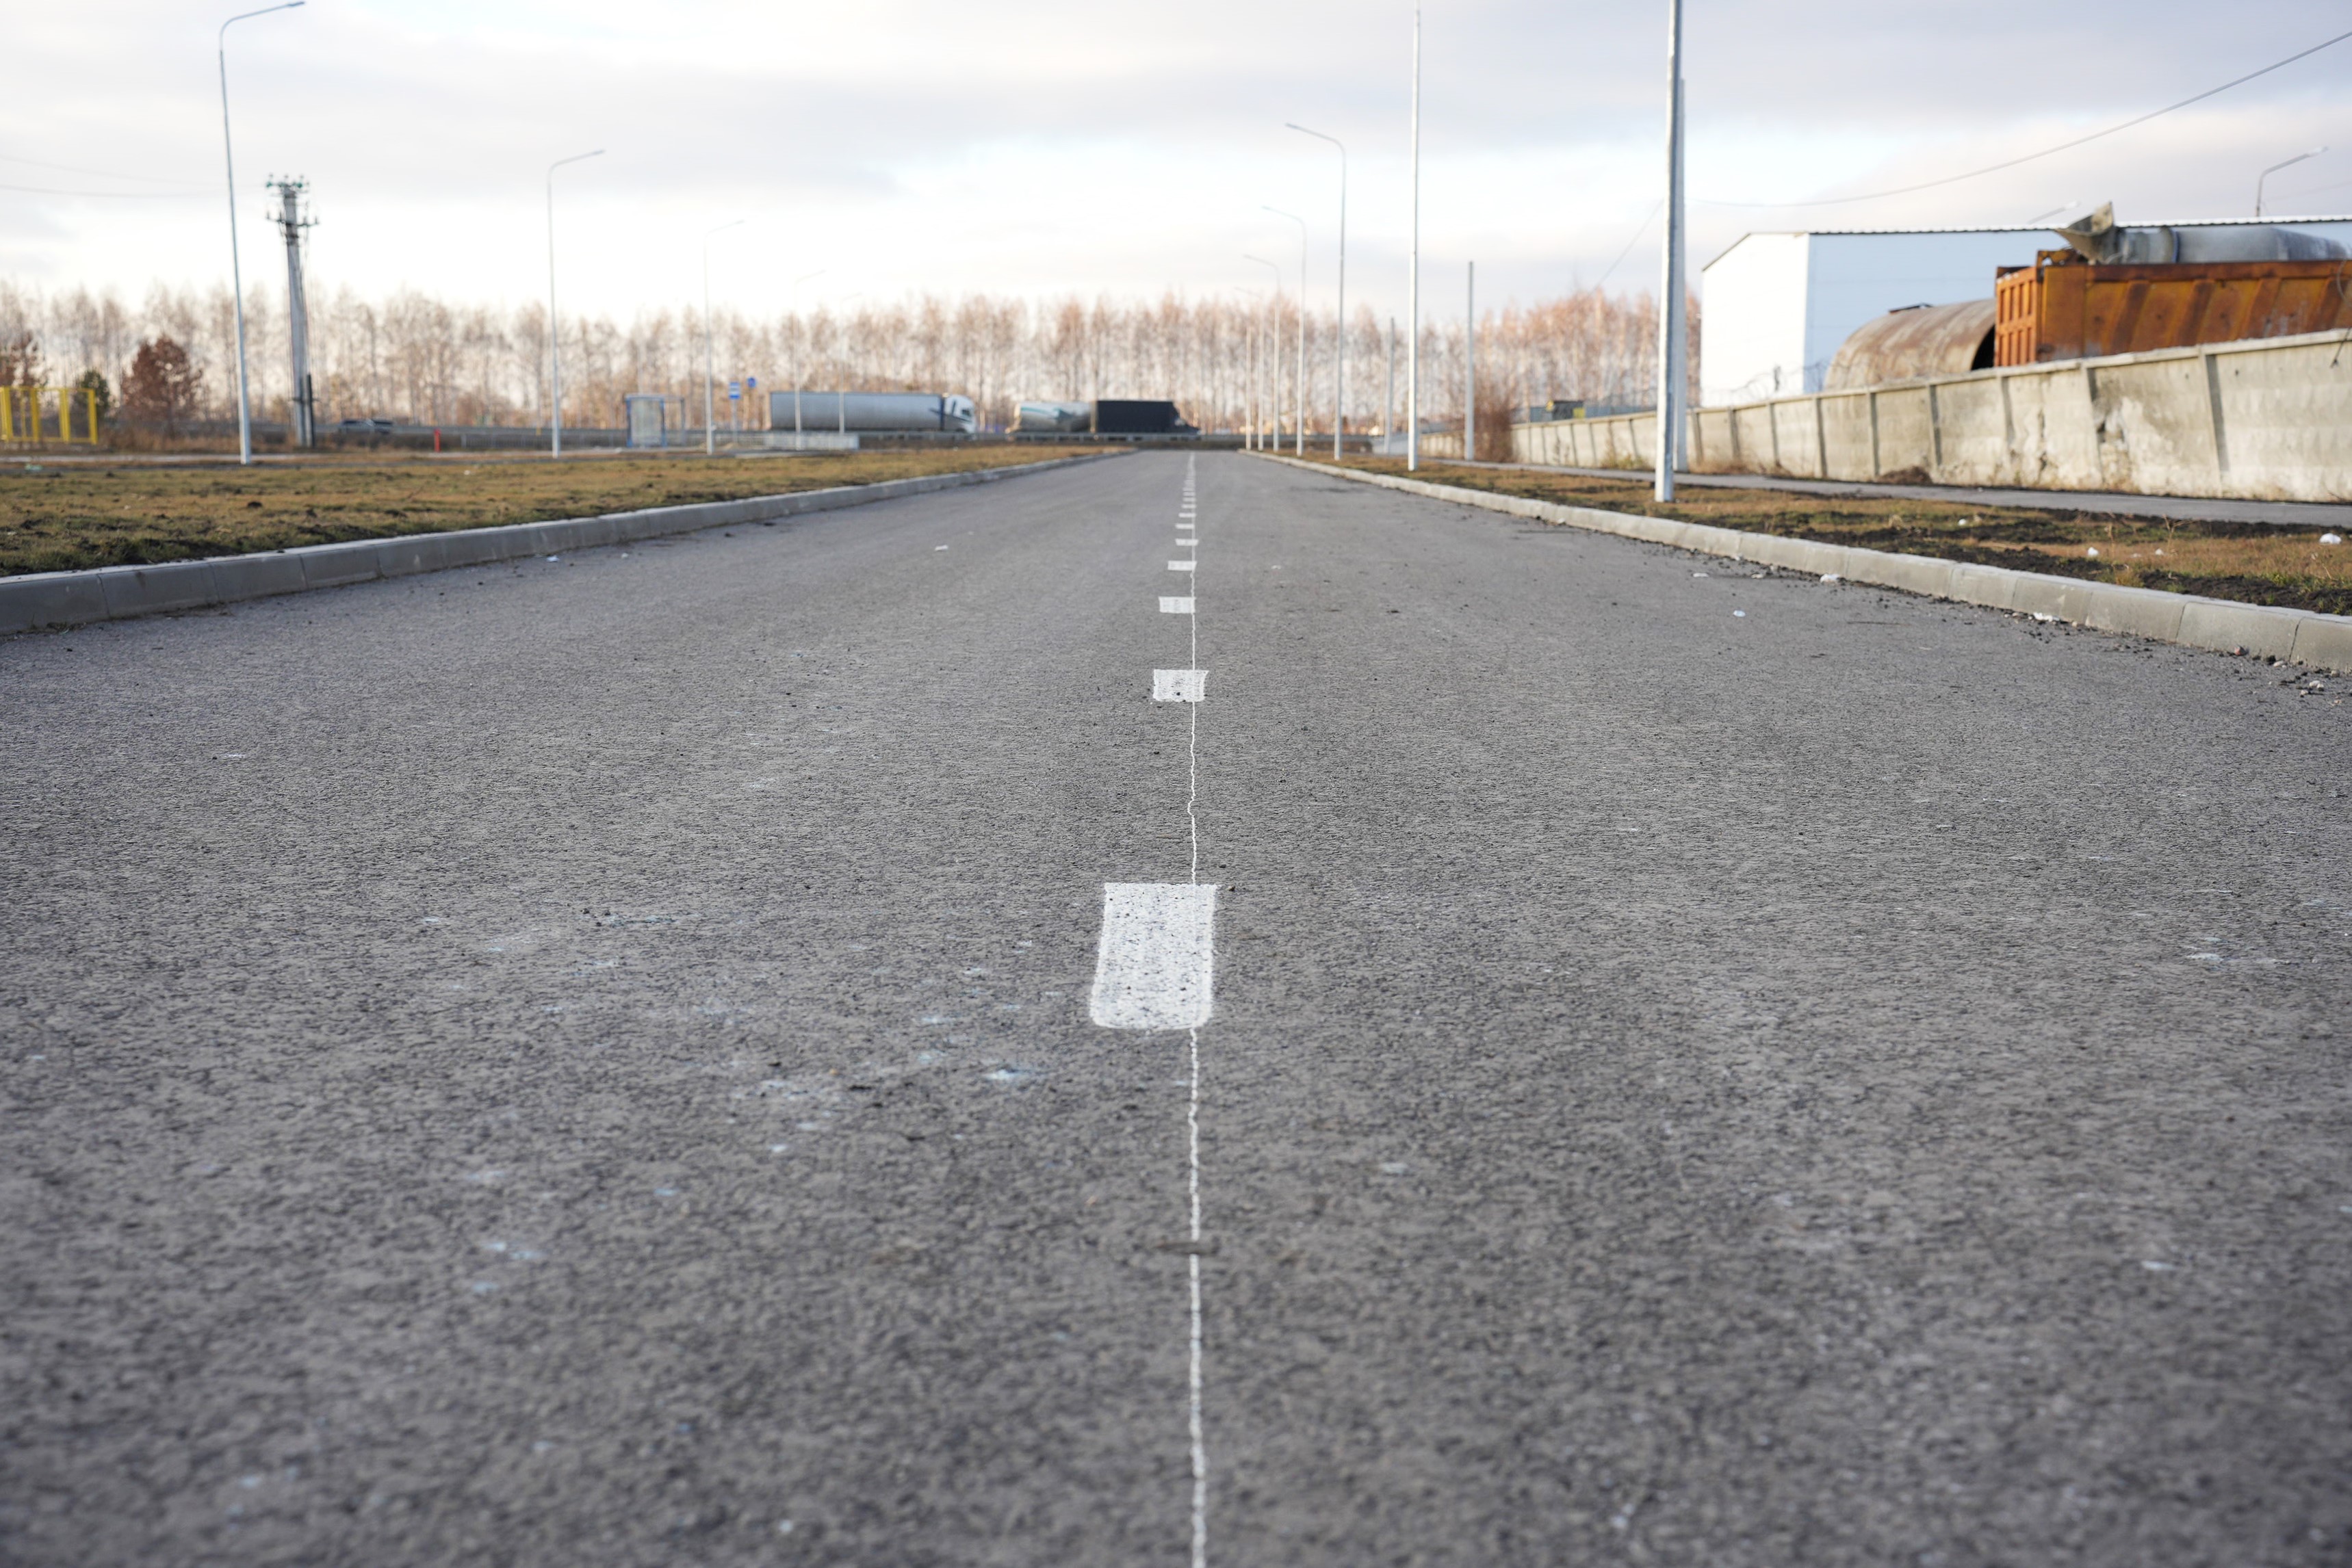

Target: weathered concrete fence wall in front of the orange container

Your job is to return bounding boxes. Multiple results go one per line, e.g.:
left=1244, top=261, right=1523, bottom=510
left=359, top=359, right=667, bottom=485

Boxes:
left=1510, top=332, right=2352, bottom=501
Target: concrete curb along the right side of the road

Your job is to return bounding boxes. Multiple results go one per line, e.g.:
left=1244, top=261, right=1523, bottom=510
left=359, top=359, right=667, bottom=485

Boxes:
left=1256, top=452, right=2352, bottom=675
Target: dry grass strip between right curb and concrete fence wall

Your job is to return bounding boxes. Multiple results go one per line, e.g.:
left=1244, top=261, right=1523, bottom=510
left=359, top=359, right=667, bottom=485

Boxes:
left=1347, top=458, right=2352, bottom=616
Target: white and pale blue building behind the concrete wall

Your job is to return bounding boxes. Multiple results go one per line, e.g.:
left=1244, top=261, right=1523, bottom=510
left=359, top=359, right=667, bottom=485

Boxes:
left=1698, top=219, right=2352, bottom=404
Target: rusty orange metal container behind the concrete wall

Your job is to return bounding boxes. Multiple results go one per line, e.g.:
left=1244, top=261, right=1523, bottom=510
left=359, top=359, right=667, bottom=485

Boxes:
left=1992, top=249, right=2352, bottom=365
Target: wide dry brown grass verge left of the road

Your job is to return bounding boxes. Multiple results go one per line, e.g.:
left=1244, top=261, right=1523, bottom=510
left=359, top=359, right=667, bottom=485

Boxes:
left=0, top=447, right=1091, bottom=573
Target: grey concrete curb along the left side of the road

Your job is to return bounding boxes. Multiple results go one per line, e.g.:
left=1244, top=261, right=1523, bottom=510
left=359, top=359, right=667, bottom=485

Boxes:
left=0, top=449, right=1126, bottom=637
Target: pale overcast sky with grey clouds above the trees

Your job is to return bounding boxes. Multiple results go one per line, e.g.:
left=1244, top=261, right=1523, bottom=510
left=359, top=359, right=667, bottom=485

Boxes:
left=0, top=0, right=2352, bottom=315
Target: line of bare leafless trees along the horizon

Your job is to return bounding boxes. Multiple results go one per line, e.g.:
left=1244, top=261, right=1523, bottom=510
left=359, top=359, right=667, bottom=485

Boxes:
left=0, top=280, right=1698, bottom=430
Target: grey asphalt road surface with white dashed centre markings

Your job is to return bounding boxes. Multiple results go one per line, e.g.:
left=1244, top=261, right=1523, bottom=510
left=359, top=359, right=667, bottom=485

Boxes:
left=0, top=454, right=2352, bottom=1568
